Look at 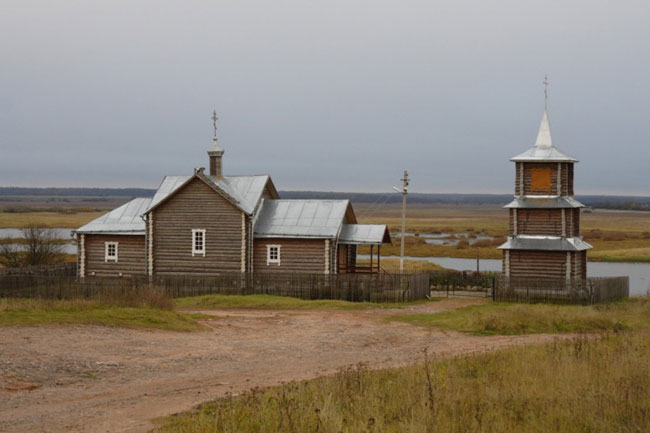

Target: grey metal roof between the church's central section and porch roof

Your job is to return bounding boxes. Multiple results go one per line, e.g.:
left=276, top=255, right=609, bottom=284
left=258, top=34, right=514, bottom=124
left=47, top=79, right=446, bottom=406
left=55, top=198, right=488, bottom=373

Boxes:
left=255, top=200, right=350, bottom=239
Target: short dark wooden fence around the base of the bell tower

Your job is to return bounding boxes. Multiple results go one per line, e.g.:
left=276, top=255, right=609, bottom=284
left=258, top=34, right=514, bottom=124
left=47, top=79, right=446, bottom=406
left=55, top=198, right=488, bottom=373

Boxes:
left=493, top=276, right=630, bottom=305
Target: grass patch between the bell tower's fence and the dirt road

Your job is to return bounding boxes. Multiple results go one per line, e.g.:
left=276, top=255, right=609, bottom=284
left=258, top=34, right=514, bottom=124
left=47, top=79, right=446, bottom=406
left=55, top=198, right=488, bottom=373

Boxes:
left=386, top=298, right=650, bottom=335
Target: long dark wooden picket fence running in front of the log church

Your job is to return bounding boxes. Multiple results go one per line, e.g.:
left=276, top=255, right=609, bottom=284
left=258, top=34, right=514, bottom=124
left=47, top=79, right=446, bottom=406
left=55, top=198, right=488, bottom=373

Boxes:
left=0, top=273, right=430, bottom=302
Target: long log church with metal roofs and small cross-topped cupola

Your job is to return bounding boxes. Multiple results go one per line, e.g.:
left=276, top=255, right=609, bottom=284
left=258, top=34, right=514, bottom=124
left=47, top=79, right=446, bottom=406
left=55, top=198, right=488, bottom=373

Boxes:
left=74, top=113, right=391, bottom=277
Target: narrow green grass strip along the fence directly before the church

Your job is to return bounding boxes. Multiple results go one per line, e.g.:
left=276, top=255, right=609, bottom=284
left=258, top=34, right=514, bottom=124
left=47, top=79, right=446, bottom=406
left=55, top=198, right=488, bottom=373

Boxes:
left=174, top=295, right=430, bottom=310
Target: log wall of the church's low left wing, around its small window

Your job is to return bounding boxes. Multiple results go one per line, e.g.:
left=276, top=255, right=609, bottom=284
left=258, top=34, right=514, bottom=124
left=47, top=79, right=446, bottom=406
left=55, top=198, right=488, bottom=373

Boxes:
left=84, top=234, right=146, bottom=277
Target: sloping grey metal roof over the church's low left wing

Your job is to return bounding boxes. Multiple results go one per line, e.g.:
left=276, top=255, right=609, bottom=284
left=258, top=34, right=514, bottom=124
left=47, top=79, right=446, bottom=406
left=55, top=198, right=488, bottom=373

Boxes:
left=73, top=198, right=152, bottom=235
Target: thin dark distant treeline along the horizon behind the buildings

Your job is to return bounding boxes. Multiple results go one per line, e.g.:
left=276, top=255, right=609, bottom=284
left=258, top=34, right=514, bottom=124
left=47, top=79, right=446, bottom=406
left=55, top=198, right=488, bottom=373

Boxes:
left=0, top=187, right=650, bottom=211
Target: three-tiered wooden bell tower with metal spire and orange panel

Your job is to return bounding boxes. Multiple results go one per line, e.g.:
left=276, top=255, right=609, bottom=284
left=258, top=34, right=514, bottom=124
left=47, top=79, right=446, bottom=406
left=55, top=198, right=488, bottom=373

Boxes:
left=499, top=105, right=591, bottom=282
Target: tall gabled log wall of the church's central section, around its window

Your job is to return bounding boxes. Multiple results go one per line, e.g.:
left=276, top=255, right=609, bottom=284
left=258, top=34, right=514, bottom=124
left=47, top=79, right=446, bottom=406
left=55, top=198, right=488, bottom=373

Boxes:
left=153, top=179, right=245, bottom=275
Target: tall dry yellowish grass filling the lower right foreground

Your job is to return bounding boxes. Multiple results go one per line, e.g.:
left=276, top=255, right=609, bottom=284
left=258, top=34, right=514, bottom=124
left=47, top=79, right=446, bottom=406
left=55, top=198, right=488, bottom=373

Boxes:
left=153, top=332, right=650, bottom=433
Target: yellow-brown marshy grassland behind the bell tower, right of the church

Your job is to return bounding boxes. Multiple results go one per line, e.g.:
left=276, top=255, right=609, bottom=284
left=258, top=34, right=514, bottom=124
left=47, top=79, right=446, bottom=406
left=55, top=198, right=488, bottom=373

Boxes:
left=357, top=205, right=650, bottom=262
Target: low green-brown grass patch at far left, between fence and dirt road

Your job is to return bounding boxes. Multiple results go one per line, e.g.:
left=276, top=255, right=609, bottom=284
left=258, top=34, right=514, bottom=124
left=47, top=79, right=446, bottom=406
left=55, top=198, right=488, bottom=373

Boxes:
left=0, top=299, right=202, bottom=332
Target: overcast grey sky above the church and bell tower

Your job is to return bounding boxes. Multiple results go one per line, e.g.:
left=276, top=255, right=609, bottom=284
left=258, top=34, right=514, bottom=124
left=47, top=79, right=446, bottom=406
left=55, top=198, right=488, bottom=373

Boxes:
left=0, top=0, right=650, bottom=195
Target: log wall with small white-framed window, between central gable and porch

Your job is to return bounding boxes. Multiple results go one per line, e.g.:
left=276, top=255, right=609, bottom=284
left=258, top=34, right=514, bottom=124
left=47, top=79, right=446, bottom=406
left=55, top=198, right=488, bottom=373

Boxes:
left=253, top=238, right=325, bottom=274
